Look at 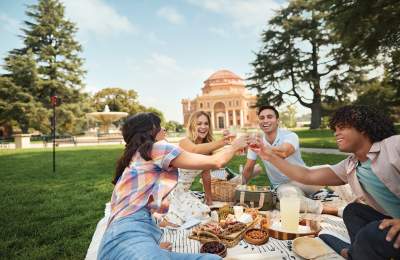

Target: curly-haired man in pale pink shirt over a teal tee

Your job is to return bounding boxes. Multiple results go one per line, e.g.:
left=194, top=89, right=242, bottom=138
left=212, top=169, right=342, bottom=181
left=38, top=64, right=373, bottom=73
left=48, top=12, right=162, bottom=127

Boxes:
left=254, top=106, right=400, bottom=260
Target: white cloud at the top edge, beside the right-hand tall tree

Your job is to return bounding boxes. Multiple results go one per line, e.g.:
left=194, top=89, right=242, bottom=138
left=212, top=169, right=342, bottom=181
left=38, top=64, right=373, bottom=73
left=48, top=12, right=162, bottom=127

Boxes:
left=187, top=0, right=282, bottom=33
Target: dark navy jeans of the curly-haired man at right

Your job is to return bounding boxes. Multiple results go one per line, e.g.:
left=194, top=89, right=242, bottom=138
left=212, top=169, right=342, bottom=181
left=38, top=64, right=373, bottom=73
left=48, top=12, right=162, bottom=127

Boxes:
left=343, top=203, right=400, bottom=260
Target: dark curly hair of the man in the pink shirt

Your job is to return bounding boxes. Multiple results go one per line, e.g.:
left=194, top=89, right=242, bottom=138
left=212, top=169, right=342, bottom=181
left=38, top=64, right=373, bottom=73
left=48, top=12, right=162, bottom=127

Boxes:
left=329, top=105, right=396, bottom=143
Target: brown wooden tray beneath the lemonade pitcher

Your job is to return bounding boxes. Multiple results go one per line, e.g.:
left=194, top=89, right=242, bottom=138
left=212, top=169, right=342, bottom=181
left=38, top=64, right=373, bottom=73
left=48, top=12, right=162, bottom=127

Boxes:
left=268, top=220, right=321, bottom=240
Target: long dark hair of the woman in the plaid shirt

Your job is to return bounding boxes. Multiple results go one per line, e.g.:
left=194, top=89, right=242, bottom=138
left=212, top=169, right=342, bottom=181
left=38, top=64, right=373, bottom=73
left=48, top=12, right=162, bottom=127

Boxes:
left=112, top=113, right=161, bottom=185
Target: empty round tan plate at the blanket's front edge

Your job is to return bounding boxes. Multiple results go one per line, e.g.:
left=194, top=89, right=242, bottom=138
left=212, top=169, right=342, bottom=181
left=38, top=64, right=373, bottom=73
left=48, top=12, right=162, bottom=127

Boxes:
left=292, top=237, right=329, bottom=259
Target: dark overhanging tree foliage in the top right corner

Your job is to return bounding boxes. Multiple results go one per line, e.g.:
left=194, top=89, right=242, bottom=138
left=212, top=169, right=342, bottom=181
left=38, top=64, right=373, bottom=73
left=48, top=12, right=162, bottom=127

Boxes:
left=319, top=0, right=400, bottom=57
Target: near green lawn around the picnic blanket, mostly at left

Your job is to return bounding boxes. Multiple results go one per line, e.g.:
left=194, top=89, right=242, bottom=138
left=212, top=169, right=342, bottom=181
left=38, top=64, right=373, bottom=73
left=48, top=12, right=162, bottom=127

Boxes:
left=0, top=145, right=343, bottom=259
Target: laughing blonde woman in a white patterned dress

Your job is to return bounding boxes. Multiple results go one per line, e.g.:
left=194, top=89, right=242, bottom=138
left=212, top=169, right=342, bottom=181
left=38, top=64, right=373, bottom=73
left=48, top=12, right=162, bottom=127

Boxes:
left=165, top=111, right=232, bottom=225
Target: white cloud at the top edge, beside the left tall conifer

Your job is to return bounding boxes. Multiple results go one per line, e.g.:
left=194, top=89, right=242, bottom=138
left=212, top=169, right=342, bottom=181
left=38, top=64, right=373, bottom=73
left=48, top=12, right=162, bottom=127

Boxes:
left=63, top=0, right=138, bottom=36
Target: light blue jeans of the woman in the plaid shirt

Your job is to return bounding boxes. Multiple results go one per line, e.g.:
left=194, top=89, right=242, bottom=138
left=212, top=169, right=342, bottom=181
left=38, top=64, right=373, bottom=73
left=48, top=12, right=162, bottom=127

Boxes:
left=97, top=209, right=221, bottom=260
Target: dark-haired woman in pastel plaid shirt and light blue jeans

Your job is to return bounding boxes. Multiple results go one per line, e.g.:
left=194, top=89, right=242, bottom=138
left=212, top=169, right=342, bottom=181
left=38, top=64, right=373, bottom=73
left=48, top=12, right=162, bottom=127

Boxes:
left=98, top=113, right=247, bottom=260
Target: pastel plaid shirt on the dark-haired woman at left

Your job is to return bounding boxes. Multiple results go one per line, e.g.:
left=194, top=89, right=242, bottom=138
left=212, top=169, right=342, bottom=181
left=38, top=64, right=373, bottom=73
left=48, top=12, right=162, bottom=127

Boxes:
left=109, top=141, right=181, bottom=224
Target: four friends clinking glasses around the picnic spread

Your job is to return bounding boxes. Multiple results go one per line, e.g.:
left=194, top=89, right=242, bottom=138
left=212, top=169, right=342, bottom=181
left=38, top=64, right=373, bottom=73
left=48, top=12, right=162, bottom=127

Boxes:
left=98, top=106, right=400, bottom=259
